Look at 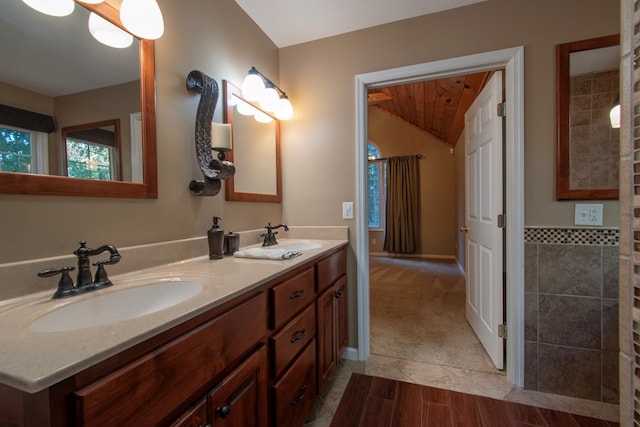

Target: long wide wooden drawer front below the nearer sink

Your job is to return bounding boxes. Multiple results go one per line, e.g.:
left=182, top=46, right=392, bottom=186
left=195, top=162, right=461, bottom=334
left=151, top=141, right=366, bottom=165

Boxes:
left=75, top=293, right=267, bottom=426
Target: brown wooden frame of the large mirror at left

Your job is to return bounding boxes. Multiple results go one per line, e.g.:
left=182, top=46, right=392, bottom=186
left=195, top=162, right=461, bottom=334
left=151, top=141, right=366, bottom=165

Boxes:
left=0, top=1, right=158, bottom=199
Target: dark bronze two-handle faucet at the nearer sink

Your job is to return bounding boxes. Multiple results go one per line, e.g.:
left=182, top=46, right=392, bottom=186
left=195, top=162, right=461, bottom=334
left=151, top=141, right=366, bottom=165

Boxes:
left=38, top=240, right=121, bottom=299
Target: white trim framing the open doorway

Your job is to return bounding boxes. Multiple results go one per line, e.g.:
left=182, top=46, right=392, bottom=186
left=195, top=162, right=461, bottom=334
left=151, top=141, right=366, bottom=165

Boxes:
left=355, top=46, right=524, bottom=387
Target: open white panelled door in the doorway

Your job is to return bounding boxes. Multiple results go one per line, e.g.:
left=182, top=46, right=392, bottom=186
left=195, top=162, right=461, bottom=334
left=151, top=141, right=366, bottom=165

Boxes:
left=462, top=71, right=504, bottom=369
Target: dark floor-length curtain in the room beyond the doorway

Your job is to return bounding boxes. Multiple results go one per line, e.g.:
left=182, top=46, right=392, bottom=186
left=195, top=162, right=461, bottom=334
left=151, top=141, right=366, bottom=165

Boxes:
left=383, top=156, right=420, bottom=254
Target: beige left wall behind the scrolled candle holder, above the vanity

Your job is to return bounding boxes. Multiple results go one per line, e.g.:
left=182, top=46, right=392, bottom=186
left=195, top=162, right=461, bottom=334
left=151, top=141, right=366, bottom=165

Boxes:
left=0, top=0, right=282, bottom=264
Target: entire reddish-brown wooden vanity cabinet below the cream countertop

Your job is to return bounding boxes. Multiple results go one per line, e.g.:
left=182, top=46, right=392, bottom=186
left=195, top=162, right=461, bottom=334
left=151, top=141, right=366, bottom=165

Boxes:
left=0, top=248, right=347, bottom=427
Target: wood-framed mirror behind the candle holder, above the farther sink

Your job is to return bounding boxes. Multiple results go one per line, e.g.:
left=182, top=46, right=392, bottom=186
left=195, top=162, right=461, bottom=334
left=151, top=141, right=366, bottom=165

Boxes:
left=222, top=80, right=282, bottom=203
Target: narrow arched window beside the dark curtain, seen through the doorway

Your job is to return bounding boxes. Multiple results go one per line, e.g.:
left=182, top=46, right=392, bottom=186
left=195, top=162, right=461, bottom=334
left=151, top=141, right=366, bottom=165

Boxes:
left=367, top=142, right=387, bottom=230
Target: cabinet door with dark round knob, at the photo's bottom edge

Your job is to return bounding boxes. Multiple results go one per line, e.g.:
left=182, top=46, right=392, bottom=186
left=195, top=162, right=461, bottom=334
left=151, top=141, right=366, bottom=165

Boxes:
left=209, top=347, right=267, bottom=427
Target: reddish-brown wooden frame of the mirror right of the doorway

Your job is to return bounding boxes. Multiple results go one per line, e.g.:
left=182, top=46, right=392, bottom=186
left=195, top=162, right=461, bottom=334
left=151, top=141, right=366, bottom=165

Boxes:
left=556, top=34, right=620, bottom=200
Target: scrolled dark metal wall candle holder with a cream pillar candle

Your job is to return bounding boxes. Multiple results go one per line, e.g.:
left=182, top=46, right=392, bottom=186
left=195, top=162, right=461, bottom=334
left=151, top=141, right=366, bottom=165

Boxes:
left=187, top=70, right=236, bottom=196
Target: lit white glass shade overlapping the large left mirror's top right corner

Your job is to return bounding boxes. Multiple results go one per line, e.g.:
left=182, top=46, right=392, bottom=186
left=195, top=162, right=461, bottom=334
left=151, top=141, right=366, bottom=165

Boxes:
left=120, top=0, right=164, bottom=40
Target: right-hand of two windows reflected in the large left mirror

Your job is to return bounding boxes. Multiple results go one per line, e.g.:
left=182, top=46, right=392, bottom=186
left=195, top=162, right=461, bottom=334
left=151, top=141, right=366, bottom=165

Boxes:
left=67, top=138, right=114, bottom=181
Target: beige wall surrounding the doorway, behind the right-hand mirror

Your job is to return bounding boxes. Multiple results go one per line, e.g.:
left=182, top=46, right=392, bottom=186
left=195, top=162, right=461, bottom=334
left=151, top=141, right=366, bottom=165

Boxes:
left=280, top=0, right=619, bottom=233
